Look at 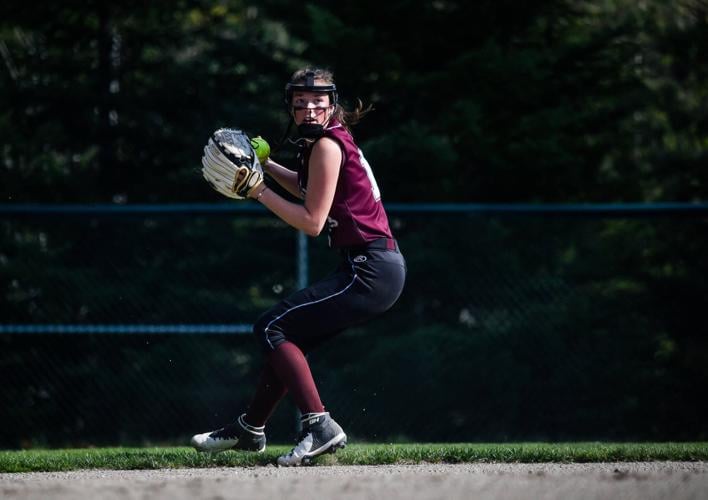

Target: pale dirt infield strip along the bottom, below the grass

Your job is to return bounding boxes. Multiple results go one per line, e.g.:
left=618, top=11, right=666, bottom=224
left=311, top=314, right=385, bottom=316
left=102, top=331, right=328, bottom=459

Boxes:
left=0, top=462, right=708, bottom=500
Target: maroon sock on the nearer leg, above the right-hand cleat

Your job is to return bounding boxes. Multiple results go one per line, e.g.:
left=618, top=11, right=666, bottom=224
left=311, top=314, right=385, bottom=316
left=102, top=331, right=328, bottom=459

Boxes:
left=268, top=342, right=324, bottom=414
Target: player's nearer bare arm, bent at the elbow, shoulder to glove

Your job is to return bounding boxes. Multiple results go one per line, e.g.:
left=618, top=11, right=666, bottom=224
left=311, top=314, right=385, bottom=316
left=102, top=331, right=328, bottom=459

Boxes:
left=253, top=137, right=342, bottom=236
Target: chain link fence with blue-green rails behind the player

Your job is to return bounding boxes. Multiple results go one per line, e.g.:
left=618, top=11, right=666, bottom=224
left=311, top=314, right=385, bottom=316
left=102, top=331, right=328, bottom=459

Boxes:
left=0, top=205, right=708, bottom=448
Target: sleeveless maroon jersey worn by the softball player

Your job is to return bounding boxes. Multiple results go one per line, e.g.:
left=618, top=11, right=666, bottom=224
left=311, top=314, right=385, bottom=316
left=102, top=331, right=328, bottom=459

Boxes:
left=298, top=121, right=393, bottom=247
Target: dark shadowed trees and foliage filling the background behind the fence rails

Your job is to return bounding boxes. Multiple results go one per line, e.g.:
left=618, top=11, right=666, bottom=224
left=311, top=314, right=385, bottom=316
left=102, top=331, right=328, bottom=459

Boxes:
left=0, top=0, right=708, bottom=447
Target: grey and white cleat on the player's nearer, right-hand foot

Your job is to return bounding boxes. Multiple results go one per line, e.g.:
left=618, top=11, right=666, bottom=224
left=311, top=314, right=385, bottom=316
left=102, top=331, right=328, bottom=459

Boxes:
left=278, top=413, right=347, bottom=467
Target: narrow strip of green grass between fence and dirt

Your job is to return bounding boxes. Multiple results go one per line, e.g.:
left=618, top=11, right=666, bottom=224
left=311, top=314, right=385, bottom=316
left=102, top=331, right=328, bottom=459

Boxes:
left=0, top=443, right=708, bottom=472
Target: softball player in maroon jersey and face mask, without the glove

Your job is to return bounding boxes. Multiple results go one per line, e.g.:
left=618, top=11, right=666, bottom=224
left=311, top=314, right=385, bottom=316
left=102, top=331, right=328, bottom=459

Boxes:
left=192, top=68, right=406, bottom=466
